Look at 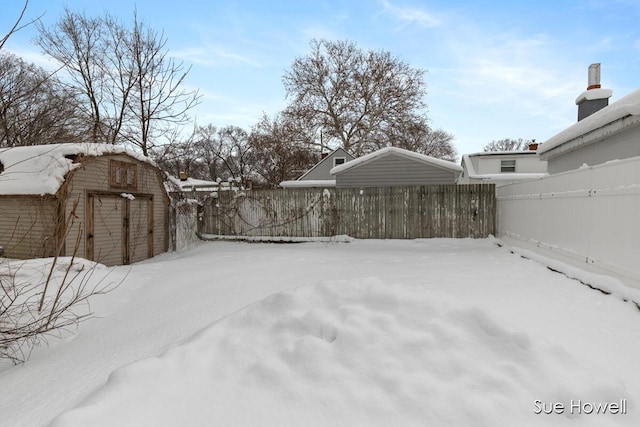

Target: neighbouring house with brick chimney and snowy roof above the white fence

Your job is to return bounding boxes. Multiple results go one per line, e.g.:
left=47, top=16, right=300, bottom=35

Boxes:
left=538, top=64, right=640, bottom=174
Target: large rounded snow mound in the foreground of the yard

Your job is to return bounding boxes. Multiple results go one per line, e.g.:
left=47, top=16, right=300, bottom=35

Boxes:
left=53, top=278, right=633, bottom=427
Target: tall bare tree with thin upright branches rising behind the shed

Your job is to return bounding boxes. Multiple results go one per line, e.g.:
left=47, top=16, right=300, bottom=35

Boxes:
left=36, top=9, right=199, bottom=155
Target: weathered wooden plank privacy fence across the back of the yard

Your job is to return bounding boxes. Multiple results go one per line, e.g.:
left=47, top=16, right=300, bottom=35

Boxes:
left=198, top=184, right=496, bottom=239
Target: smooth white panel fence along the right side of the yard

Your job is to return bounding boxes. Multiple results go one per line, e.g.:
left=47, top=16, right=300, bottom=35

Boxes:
left=496, top=157, right=640, bottom=284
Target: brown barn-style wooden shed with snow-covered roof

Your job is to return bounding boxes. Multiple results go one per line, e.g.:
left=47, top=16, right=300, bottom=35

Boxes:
left=0, top=144, right=169, bottom=265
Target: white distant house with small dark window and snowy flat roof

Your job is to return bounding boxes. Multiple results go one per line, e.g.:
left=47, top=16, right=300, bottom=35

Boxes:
left=458, top=148, right=547, bottom=186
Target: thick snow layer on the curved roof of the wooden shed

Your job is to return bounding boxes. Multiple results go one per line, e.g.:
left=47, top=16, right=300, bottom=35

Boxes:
left=0, top=143, right=154, bottom=196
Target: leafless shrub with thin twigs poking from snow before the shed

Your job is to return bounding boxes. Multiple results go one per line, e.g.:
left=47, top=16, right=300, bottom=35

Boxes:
left=0, top=214, right=118, bottom=364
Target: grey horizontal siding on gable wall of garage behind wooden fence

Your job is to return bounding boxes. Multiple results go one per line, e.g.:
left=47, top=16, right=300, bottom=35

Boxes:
left=336, top=154, right=458, bottom=188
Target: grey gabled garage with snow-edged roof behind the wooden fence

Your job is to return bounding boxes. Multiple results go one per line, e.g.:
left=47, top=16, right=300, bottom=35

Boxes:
left=330, top=147, right=462, bottom=188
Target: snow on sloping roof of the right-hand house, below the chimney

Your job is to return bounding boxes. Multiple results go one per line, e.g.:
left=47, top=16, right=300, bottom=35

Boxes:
left=538, top=89, right=640, bottom=154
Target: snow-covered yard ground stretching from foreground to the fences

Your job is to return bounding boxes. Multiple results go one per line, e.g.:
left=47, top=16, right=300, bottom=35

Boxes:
left=0, top=239, right=640, bottom=427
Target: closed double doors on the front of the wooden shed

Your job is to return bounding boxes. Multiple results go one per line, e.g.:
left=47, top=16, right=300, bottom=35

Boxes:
left=86, top=194, right=153, bottom=265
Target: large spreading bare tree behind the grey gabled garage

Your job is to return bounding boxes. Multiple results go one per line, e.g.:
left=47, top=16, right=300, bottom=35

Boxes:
left=283, top=40, right=450, bottom=156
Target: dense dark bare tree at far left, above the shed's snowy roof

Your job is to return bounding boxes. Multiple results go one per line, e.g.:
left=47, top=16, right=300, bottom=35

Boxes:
left=0, top=54, right=80, bottom=147
